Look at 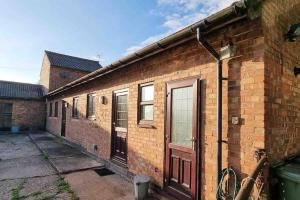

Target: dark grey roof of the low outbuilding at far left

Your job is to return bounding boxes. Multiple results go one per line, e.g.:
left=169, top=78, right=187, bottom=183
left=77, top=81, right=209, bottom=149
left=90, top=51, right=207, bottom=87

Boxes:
left=0, top=80, right=44, bottom=99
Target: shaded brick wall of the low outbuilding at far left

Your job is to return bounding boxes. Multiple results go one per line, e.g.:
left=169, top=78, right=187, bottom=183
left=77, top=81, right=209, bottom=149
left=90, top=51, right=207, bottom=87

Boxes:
left=0, top=99, right=46, bottom=130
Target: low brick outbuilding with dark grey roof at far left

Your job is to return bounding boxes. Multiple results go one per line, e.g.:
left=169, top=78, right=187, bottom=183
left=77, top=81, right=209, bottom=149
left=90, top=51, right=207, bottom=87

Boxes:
left=0, top=81, right=46, bottom=131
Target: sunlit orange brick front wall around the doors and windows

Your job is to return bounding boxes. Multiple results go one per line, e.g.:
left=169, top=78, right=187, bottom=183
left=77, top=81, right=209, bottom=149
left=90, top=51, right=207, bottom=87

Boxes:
left=47, top=17, right=265, bottom=199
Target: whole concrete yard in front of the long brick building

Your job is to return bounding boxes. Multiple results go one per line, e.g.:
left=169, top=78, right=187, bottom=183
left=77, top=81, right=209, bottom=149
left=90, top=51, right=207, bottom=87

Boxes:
left=0, top=132, right=133, bottom=200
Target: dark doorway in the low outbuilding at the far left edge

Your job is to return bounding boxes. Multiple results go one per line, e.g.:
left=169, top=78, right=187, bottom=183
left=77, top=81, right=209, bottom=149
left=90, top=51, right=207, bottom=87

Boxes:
left=0, top=103, right=12, bottom=131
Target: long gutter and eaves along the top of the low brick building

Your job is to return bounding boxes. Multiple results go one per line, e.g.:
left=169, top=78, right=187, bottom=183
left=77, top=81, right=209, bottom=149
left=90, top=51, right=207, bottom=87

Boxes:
left=46, top=0, right=262, bottom=97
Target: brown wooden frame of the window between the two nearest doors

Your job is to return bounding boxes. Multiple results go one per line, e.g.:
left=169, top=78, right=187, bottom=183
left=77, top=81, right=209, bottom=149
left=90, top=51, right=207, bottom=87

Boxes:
left=137, top=82, right=155, bottom=125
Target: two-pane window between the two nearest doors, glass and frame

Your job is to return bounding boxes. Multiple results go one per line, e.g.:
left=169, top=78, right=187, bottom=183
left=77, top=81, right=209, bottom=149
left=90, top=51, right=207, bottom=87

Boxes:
left=139, top=83, right=154, bottom=124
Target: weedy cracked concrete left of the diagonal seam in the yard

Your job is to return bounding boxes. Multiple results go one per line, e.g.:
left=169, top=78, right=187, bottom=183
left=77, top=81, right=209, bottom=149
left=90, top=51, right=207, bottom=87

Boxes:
left=0, top=132, right=75, bottom=200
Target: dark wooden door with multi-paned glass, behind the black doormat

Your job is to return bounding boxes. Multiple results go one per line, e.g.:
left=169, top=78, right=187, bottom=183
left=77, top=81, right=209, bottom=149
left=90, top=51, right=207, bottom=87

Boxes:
left=112, top=90, right=128, bottom=165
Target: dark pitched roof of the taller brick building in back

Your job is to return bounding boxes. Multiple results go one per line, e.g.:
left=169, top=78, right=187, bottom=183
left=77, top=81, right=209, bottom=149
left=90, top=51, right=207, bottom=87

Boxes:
left=45, top=51, right=102, bottom=72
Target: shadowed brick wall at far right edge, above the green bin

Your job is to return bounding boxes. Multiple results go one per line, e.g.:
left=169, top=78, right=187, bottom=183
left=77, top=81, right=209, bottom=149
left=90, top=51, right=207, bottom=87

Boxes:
left=262, top=0, right=300, bottom=162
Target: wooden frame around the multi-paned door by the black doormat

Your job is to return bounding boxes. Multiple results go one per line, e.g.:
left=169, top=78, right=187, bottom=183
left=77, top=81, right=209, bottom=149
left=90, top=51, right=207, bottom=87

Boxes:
left=110, top=88, right=129, bottom=167
